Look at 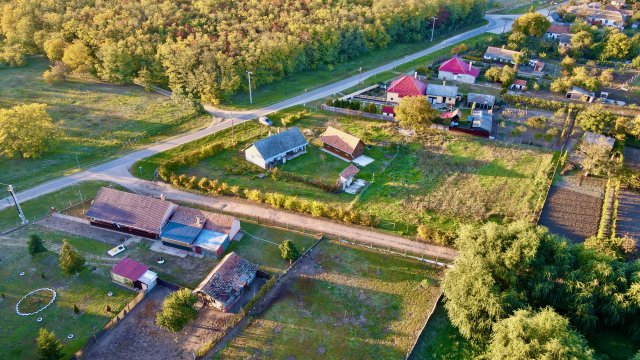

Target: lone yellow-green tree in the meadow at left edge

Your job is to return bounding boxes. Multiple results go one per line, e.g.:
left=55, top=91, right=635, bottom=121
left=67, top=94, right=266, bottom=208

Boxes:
left=0, top=104, right=56, bottom=158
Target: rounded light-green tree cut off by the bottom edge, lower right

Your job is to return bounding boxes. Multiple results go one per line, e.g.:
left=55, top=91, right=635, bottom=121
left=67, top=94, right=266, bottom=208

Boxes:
left=487, top=307, right=594, bottom=360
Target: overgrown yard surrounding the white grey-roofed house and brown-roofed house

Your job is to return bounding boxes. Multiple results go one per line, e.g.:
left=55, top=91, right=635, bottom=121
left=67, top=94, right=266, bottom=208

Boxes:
left=136, top=107, right=554, bottom=243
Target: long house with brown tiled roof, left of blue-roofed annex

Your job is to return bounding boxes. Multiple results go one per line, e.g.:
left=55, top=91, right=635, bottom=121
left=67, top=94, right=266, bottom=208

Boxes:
left=86, top=187, right=177, bottom=239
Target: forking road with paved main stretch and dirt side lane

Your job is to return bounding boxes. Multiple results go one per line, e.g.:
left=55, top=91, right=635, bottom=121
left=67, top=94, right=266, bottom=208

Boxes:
left=0, top=9, right=546, bottom=258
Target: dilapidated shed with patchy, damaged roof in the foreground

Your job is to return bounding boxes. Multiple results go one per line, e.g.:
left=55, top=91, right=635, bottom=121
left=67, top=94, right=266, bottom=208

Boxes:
left=193, top=252, right=258, bottom=312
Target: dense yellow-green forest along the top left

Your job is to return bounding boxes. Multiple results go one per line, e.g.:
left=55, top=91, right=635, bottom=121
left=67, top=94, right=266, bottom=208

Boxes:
left=0, top=0, right=485, bottom=104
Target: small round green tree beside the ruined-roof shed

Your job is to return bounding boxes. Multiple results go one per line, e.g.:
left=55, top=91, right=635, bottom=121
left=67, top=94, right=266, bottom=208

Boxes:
left=156, top=289, right=198, bottom=332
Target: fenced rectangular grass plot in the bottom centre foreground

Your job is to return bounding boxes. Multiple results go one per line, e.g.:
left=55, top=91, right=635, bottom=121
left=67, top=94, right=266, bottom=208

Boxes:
left=219, top=241, right=440, bottom=359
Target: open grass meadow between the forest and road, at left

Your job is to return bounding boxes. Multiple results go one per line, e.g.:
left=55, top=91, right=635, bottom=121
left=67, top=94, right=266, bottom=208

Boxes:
left=0, top=58, right=210, bottom=190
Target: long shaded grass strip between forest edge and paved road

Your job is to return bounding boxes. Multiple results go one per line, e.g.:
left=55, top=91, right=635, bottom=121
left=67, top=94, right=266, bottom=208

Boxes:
left=222, top=20, right=486, bottom=109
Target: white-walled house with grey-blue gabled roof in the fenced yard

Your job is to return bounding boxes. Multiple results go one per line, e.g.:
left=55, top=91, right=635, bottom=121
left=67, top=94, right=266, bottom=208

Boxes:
left=244, top=126, right=309, bottom=169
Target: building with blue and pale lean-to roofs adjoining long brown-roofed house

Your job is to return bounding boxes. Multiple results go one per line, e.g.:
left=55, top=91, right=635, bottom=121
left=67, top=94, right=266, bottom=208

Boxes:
left=160, top=206, right=240, bottom=258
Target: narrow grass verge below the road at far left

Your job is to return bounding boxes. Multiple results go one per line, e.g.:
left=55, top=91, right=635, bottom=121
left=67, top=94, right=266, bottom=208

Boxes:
left=0, top=181, right=117, bottom=232
